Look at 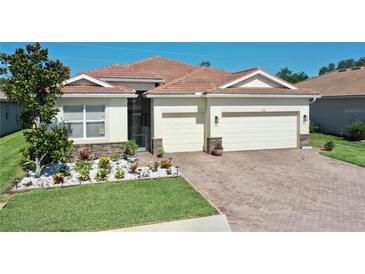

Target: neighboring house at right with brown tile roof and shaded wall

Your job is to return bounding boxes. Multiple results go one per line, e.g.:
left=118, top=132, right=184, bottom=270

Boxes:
left=297, top=67, right=365, bottom=135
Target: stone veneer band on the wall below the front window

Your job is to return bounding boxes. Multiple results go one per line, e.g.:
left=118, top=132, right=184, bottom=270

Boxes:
left=73, top=142, right=127, bottom=159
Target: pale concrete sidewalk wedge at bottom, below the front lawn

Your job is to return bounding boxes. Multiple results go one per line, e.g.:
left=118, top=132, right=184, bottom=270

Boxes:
left=109, top=215, right=231, bottom=232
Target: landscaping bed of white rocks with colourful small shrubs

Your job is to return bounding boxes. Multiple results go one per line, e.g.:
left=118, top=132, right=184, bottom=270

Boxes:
left=13, top=157, right=179, bottom=191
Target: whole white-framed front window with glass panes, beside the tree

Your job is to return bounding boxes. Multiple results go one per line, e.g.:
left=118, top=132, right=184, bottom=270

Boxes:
left=63, top=105, right=105, bottom=139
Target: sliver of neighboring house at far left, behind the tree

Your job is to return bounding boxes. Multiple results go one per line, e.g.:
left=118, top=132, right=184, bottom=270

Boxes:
left=0, top=90, right=21, bottom=136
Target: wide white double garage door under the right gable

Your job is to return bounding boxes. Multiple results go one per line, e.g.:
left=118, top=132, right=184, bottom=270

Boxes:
left=221, top=112, right=298, bottom=151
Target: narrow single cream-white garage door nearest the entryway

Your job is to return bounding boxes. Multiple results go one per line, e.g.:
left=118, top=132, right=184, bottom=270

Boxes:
left=162, top=113, right=204, bottom=152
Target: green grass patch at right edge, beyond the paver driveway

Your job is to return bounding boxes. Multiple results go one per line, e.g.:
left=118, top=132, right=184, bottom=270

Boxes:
left=310, top=133, right=365, bottom=167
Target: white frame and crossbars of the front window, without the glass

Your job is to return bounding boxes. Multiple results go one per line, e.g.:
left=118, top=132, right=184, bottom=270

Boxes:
left=62, top=104, right=107, bottom=141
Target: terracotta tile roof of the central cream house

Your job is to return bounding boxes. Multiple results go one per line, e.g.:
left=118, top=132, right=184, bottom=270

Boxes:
left=64, top=57, right=318, bottom=94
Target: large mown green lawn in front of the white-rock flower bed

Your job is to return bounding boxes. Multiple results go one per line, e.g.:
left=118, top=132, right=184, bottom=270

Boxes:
left=0, top=177, right=216, bottom=231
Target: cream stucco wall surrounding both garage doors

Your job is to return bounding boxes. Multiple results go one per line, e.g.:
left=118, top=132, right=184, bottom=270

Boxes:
left=151, top=98, right=309, bottom=151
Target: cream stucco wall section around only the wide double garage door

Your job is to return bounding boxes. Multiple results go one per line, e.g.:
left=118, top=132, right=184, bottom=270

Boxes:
left=206, top=98, right=309, bottom=137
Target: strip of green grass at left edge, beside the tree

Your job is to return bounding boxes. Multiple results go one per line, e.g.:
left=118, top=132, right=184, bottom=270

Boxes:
left=0, top=131, right=25, bottom=193
